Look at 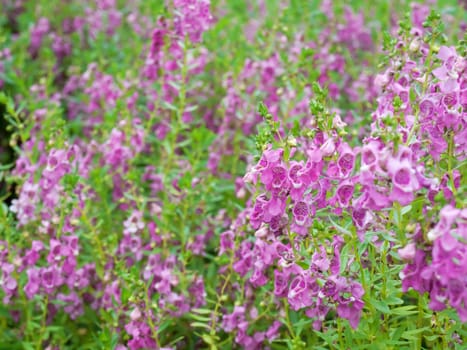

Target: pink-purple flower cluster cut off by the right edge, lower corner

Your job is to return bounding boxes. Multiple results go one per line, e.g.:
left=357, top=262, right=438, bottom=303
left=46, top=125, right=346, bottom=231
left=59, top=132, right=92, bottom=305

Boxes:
left=399, top=205, right=467, bottom=322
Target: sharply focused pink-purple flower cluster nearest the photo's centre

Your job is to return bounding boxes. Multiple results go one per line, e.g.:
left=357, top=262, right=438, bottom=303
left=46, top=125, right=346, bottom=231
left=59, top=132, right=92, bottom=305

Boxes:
left=225, top=129, right=363, bottom=329
